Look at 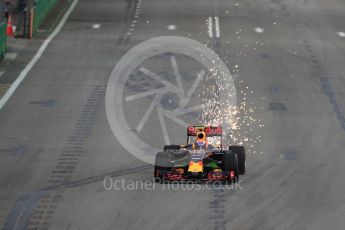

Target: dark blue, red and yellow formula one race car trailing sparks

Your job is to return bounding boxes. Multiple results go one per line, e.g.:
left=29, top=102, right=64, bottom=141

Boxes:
left=154, top=126, right=246, bottom=182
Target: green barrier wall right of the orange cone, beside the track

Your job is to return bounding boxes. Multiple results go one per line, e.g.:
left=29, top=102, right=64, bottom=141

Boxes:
left=33, top=0, right=58, bottom=33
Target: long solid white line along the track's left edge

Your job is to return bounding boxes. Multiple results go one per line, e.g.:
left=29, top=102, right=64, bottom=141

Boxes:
left=0, top=0, right=79, bottom=110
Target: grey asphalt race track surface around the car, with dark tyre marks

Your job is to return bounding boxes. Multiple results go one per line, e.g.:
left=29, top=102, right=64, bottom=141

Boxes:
left=0, top=0, right=345, bottom=230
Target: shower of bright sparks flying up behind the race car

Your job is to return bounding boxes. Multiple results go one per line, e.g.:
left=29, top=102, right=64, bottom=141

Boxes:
left=198, top=54, right=264, bottom=153
